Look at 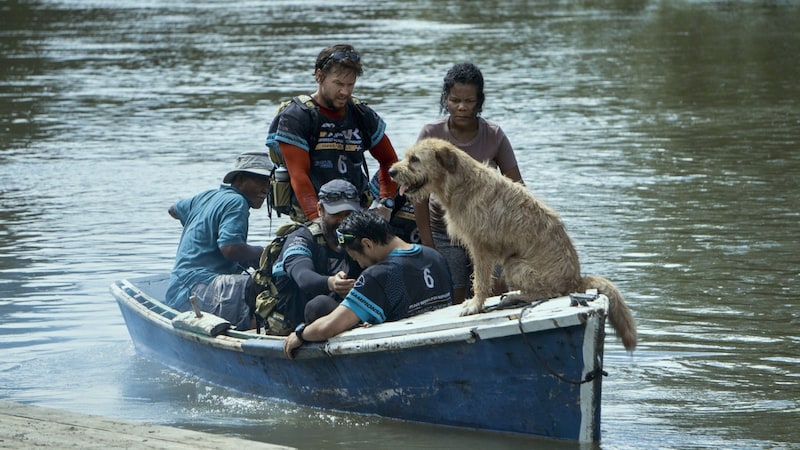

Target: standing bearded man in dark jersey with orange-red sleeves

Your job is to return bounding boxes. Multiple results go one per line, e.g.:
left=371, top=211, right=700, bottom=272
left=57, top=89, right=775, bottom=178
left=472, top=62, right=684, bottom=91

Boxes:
left=266, top=44, right=397, bottom=221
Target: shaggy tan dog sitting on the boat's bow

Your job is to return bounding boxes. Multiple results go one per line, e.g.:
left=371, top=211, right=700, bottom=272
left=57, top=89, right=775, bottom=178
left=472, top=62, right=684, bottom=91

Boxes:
left=389, top=139, right=636, bottom=351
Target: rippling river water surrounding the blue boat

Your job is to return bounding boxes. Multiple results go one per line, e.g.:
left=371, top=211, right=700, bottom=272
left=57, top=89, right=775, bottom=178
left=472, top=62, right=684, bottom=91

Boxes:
left=0, top=0, right=800, bottom=449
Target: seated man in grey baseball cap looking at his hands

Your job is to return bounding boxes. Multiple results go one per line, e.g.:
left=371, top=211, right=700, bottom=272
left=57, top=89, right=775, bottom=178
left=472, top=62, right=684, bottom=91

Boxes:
left=267, top=179, right=362, bottom=335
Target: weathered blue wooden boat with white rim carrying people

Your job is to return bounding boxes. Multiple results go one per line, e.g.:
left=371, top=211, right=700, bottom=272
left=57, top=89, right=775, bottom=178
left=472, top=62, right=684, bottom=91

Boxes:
left=111, top=274, right=608, bottom=442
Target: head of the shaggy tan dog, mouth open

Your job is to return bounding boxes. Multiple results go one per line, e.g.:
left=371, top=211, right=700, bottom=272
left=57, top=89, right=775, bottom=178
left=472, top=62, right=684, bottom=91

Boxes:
left=389, top=138, right=463, bottom=200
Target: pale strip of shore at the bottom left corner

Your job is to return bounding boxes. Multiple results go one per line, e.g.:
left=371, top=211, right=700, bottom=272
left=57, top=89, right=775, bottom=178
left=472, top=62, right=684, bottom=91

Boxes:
left=0, top=401, right=291, bottom=450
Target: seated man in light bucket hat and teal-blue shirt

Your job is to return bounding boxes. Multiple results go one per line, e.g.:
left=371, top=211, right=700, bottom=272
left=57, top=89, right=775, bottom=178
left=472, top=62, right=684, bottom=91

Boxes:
left=166, top=153, right=273, bottom=330
